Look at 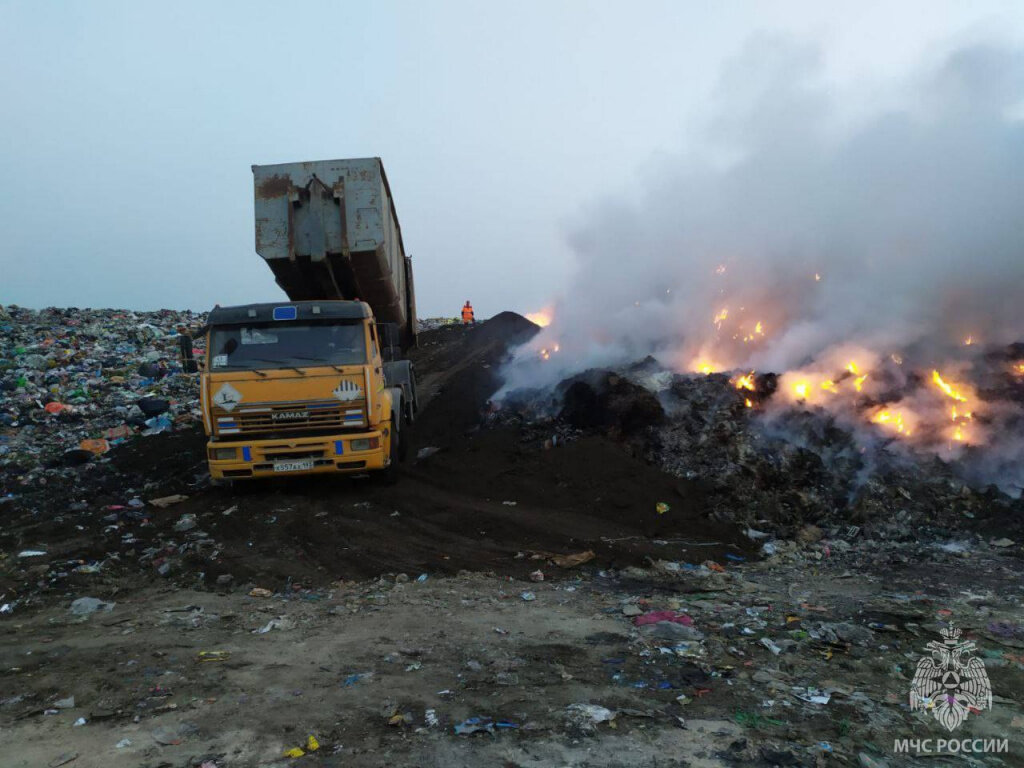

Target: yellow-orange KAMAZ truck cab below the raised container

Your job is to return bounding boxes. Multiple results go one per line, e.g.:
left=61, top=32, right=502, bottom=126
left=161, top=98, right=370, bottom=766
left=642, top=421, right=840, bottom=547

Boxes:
left=200, top=301, right=417, bottom=480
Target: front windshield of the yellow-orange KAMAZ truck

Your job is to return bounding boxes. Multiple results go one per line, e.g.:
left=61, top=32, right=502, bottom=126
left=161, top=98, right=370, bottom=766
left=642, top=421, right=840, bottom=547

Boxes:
left=210, top=323, right=367, bottom=371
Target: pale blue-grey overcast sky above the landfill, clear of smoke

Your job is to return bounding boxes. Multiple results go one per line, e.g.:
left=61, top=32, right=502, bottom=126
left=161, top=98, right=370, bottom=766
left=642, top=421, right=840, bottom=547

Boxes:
left=0, top=0, right=1024, bottom=316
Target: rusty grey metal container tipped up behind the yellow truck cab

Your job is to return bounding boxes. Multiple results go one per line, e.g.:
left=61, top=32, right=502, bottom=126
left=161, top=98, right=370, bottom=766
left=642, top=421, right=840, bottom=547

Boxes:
left=252, top=158, right=416, bottom=347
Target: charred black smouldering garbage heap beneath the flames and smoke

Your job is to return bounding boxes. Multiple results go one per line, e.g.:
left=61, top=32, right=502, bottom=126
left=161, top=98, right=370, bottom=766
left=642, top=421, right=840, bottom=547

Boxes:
left=492, top=357, right=1024, bottom=540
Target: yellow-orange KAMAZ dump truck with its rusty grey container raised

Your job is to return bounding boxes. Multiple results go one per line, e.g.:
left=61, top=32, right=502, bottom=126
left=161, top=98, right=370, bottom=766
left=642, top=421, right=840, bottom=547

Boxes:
left=182, top=158, right=418, bottom=481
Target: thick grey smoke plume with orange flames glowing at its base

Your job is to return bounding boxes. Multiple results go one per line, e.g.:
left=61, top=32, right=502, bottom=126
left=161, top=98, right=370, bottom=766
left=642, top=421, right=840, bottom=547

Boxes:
left=505, top=40, right=1024, bottom=493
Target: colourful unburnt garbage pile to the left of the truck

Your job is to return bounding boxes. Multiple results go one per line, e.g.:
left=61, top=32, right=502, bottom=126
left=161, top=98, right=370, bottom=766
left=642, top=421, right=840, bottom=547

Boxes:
left=0, top=306, right=204, bottom=499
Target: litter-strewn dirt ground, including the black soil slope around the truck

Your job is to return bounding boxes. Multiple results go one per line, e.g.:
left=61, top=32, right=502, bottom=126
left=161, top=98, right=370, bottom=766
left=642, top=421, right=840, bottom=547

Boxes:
left=0, top=315, right=1024, bottom=768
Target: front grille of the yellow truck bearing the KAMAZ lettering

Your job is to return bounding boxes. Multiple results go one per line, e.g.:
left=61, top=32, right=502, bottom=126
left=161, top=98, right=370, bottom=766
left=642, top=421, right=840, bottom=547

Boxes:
left=217, top=400, right=367, bottom=435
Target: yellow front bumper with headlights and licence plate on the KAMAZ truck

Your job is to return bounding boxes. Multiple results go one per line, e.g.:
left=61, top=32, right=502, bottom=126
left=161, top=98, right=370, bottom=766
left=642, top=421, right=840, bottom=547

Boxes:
left=206, top=429, right=390, bottom=480
